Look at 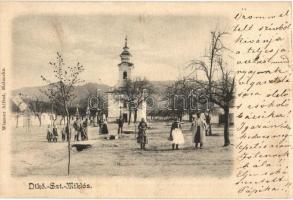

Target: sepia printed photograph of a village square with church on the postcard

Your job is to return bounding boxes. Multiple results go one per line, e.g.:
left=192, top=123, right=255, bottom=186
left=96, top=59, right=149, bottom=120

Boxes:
left=11, top=15, right=235, bottom=177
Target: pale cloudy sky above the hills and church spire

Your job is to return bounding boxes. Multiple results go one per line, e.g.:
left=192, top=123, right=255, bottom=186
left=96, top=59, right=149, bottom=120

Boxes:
left=12, top=14, right=229, bottom=89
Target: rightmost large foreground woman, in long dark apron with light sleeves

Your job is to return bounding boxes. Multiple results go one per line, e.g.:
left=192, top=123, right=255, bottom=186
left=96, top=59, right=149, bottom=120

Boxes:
left=192, top=113, right=206, bottom=149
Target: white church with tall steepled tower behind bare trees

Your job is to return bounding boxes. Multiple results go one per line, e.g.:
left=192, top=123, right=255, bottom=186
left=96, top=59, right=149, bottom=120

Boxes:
left=108, top=38, right=146, bottom=122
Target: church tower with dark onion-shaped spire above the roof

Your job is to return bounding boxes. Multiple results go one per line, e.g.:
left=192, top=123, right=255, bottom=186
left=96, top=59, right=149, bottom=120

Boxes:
left=118, top=37, right=134, bottom=87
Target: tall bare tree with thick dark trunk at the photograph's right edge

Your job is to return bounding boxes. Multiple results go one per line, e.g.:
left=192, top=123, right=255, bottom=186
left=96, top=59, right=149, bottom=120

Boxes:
left=188, top=32, right=235, bottom=146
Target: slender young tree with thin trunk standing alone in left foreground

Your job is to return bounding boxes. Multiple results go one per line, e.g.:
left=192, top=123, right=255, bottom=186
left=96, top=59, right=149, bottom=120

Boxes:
left=41, top=52, right=84, bottom=175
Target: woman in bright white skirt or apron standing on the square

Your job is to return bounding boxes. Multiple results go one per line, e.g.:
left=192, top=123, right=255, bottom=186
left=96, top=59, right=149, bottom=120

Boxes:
left=169, top=118, right=184, bottom=150
